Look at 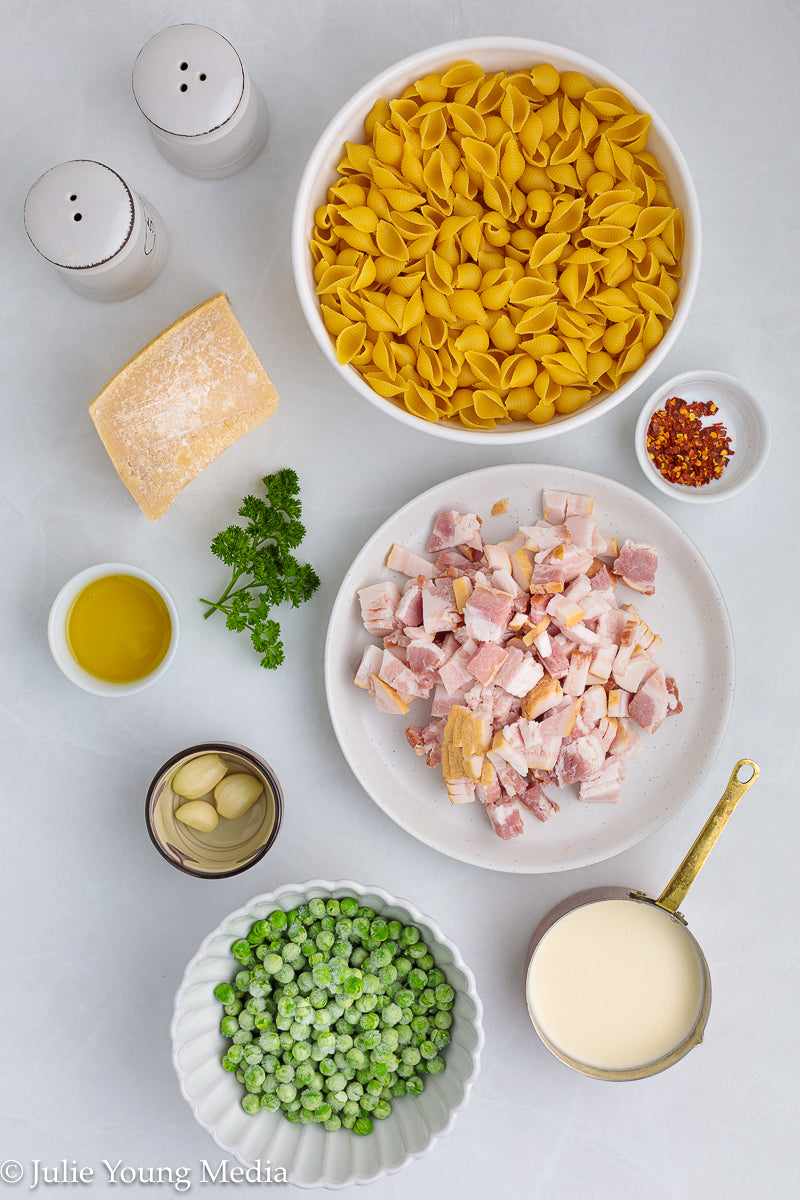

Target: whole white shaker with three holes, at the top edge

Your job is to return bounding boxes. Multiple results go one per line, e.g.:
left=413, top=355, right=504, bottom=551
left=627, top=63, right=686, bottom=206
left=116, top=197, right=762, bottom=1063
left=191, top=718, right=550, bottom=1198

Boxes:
left=132, top=24, right=267, bottom=179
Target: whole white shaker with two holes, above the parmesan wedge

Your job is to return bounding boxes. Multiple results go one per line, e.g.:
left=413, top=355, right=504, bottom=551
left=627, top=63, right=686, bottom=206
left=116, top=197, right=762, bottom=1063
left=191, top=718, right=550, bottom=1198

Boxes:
left=25, top=158, right=167, bottom=300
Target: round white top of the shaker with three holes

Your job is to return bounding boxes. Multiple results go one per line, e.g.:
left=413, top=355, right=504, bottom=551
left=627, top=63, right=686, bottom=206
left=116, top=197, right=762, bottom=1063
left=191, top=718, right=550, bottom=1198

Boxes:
left=132, top=24, right=245, bottom=137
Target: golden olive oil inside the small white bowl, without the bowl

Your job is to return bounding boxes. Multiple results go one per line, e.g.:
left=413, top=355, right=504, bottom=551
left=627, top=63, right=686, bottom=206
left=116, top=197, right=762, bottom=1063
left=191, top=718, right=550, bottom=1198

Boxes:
left=66, top=575, right=173, bottom=683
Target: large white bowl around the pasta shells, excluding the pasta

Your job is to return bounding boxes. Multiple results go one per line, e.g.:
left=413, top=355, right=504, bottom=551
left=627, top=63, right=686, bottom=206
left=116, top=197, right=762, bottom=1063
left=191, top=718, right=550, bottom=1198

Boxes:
left=291, top=37, right=700, bottom=445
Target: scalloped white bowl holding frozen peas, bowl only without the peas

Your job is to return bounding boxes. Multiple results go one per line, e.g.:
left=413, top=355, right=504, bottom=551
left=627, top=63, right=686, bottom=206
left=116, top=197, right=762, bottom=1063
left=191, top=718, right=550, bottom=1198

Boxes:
left=170, top=880, right=483, bottom=1188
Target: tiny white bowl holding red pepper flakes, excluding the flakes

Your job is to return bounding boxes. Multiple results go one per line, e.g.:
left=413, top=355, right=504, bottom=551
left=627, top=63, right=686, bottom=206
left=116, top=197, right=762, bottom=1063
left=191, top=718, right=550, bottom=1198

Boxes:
left=634, top=371, right=771, bottom=504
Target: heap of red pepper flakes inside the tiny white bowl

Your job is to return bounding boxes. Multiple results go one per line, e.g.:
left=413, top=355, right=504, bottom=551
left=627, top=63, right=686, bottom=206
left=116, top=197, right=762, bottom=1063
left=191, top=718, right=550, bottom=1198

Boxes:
left=646, top=396, right=733, bottom=487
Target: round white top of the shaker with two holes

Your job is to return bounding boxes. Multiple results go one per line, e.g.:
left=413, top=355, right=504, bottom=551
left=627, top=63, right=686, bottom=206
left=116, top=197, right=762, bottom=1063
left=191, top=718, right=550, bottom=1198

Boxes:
left=25, top=158, right=134, bottom=270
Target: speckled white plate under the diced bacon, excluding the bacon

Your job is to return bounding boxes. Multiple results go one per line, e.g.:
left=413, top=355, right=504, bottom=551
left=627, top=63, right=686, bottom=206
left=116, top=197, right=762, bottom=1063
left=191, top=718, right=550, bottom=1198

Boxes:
left=325, top=464, right=735, bottom=874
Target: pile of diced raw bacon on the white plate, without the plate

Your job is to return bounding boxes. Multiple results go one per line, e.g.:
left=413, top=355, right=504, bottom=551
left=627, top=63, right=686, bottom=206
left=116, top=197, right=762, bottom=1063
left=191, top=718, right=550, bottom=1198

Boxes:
left=354, top=491, right=682, bottom=840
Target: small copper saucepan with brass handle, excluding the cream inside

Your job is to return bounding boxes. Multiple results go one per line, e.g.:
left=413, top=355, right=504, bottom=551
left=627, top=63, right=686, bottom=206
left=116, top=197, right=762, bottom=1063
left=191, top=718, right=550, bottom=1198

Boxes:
left=525, top=758, right=759, bottom=1080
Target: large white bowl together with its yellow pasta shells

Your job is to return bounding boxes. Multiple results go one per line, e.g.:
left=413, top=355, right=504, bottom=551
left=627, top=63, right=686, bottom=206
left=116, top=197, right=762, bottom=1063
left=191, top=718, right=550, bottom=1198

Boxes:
left=291, top=37, right=700, bottom=444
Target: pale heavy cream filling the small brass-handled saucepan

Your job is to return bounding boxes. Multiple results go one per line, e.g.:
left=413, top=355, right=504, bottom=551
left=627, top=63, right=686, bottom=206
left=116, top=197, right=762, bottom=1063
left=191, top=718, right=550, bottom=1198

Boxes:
left=527, top=900, right=704, bottom=1070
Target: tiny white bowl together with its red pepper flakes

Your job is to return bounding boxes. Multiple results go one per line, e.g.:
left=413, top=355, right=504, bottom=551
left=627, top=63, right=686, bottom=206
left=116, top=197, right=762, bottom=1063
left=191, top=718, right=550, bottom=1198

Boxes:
left=636, top=371, right=770, bottom=504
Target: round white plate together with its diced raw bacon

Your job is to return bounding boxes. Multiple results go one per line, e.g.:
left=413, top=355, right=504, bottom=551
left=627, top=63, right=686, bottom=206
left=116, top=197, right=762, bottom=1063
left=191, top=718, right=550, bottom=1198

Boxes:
left=325, top=464, right=734, bottom=872
